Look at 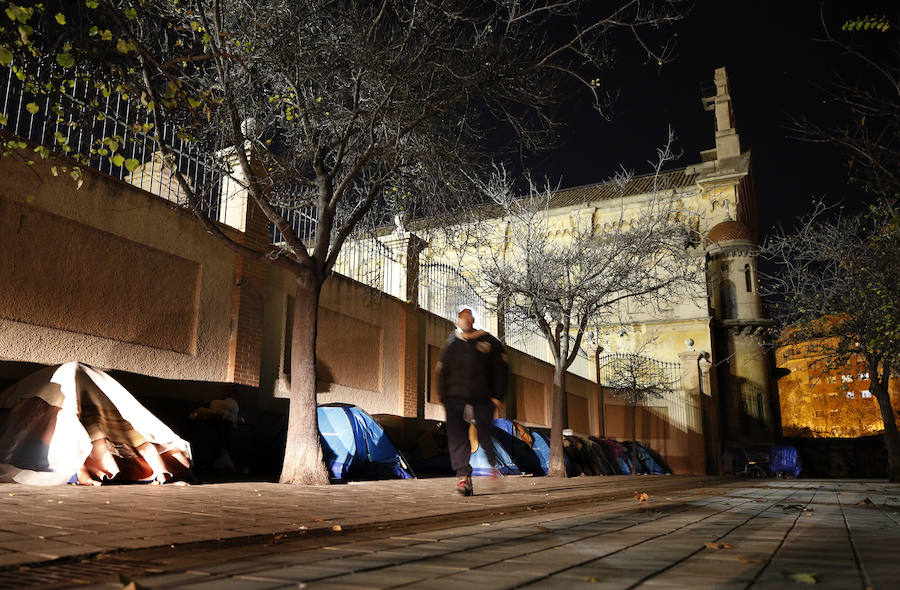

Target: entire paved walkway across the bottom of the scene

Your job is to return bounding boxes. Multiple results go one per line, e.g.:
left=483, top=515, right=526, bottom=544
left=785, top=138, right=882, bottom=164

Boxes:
left=0, top=477, right=900, bottom=589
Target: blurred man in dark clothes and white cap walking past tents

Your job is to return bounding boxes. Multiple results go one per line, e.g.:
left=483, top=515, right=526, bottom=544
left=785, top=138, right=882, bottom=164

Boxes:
left=438, top=307, right=509, bottom=496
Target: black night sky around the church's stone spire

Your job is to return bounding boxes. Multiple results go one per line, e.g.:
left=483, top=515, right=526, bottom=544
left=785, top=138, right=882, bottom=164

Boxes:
left=529, top=0, right=897, bottom=234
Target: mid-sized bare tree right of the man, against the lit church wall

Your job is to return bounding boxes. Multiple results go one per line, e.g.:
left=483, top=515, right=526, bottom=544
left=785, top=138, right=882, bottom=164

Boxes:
left=470, top=132, right=703, bottom=477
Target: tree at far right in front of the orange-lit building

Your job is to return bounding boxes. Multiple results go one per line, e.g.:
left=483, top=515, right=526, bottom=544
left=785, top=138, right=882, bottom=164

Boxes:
left=760, top=203, right=900, bottom=481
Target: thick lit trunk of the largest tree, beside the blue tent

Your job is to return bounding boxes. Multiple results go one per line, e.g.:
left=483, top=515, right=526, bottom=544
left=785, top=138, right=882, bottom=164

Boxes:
left=280, top=272, right=328, bottom=485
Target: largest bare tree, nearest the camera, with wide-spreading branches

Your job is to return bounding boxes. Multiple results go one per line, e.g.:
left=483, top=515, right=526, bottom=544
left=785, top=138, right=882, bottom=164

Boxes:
left=0, top=0, right=682, bottom=484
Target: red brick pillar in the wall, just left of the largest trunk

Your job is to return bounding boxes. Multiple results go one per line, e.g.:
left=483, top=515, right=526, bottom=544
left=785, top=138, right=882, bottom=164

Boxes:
left=229, top=183, right=269, bottom=387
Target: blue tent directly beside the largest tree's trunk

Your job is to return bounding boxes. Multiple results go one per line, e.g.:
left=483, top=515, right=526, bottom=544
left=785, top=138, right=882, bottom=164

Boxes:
left=318, top=404, right=413, bottom=480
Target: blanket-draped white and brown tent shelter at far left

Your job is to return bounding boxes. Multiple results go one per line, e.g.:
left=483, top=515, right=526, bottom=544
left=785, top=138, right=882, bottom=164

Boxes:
left=0, top=362, right=191, bottom=485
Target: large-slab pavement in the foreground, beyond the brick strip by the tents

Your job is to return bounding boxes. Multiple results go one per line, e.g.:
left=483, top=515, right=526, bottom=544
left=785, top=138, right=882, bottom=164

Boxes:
left=0, top=478, right=900, bottom=590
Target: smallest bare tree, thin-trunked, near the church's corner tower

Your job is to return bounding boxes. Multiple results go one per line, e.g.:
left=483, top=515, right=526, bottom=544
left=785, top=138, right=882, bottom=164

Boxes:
left=597, top=351, right=680, bottom=475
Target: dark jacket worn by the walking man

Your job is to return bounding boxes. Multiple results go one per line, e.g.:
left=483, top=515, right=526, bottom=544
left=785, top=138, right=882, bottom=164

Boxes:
left=438, top=330, right=509, bottom=401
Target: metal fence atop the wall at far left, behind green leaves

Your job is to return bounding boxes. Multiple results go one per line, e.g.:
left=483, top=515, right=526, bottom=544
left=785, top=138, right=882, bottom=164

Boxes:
left=0, top=67, right=227, bottom=219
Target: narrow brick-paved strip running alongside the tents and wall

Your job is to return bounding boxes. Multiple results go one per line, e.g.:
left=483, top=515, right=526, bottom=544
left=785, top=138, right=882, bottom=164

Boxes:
left=0, top=476, right=720, bottom=567
